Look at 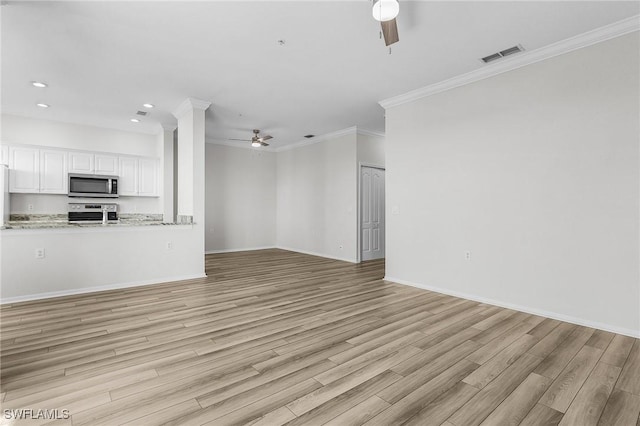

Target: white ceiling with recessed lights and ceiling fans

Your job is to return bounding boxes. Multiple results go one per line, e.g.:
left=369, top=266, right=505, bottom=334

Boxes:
left=0, top=0, right=640, bottom=147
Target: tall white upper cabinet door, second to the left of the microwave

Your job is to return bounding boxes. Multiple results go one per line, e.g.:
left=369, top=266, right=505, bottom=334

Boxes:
left=9, top=146, right=40, bottom=193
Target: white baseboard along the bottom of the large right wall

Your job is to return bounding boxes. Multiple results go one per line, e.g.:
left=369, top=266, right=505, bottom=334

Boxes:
left=384, top=276, right=640, bottom=338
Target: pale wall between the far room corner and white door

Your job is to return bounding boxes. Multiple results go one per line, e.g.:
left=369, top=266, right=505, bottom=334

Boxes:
left=277, top=132, right=357, bottom=262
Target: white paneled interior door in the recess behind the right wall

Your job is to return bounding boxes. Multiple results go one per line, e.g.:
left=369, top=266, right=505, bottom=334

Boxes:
left=360, top=167, right=385, bottom=261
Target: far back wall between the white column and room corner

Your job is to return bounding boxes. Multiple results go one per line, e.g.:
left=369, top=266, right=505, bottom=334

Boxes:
left=205, top=144, right=276, bottom=252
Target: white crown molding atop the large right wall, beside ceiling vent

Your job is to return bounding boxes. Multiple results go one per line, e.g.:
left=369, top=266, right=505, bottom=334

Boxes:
left=378, top=15, right=640, bottom=109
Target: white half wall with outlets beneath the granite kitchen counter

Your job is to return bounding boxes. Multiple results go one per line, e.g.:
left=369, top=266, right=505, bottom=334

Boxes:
left=0, top=225, right=204, bottom=303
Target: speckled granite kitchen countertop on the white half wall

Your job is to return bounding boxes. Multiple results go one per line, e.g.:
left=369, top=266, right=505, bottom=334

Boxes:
left=0, top=213, right=185, bottom=229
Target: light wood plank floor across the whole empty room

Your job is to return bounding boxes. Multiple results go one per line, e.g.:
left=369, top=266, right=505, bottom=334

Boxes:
left=0, top=250, right=640, bottom=426
